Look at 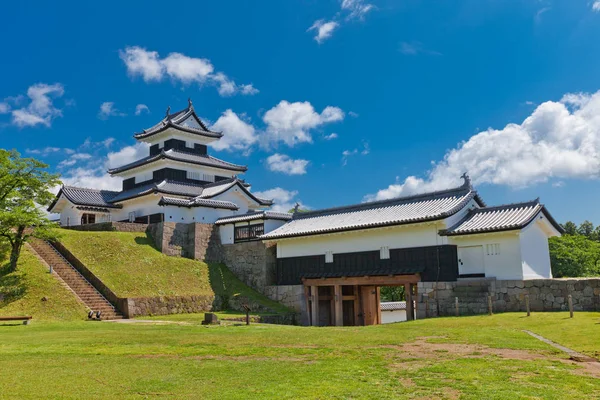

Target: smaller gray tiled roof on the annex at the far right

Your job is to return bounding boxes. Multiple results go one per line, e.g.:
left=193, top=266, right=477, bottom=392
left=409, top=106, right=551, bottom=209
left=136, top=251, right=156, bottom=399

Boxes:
left=440, top=199, right=564, bottom=236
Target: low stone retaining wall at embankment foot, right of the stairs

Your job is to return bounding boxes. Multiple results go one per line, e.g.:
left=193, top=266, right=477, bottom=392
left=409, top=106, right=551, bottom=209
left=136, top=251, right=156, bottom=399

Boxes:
left=125, top=295, right=214, bottom=318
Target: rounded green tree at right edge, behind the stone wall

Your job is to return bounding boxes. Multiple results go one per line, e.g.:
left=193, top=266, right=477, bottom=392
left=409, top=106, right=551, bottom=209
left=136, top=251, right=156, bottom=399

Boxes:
left=548, top=235, right=600, bottom=278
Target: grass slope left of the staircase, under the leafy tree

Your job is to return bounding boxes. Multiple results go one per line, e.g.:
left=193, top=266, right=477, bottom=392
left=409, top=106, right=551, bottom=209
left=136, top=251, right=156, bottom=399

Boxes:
left=0, top=248, right=87, bottom=324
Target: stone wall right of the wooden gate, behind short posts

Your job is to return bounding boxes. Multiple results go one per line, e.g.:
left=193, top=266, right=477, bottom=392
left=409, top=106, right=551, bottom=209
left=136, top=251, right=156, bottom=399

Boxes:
left=416, top=278, right=600, bottom=318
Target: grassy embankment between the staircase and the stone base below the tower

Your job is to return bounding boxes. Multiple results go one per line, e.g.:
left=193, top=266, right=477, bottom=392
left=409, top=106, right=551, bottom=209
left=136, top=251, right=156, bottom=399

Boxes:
left=60, top=229, right=290, bottom=313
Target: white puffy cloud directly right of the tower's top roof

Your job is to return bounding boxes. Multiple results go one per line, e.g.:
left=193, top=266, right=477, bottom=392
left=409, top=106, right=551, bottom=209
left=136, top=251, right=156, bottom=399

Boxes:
left=210, top=110, right=258, bottom=151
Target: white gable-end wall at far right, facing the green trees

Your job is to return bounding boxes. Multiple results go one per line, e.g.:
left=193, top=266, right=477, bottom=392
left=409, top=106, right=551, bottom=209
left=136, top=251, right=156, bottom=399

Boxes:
left=519, top=220, right=552, bottom=279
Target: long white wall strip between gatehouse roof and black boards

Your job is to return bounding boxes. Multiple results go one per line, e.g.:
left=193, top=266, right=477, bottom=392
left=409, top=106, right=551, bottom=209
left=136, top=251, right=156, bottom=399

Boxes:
left=277, top=223, right=441, bottom=258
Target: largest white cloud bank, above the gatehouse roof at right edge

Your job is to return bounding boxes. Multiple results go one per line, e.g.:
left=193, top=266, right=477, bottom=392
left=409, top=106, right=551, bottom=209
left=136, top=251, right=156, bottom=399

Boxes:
left=365, top=91, right=600, bottom=200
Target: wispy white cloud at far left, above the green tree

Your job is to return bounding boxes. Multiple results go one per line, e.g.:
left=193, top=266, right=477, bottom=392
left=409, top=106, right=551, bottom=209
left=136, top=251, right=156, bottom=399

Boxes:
left=9, top=83, right=65, bottom=128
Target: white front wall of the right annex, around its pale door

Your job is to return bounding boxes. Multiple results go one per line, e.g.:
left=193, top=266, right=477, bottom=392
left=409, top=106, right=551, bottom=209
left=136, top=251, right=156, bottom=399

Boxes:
left=448, top=231, right=523, bottom=279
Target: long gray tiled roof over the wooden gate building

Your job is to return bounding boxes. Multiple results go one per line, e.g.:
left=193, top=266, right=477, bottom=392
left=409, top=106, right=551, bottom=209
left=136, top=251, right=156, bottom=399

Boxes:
left=261, top=184, right=485, bottom=239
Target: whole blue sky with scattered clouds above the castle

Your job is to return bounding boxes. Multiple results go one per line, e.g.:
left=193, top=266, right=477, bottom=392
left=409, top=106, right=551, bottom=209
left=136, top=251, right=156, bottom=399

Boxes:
left=0, top=0, right=600, bottom=224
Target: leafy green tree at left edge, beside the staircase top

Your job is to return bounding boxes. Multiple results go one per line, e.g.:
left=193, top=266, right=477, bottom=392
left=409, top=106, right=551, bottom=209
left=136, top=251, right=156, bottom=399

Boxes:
left=0, top=149, right=60, bottom=271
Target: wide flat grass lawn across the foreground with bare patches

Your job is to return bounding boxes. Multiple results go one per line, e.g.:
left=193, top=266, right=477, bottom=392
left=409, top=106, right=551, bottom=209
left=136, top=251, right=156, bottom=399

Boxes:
left=0, top=313, right=600, bottom=399
